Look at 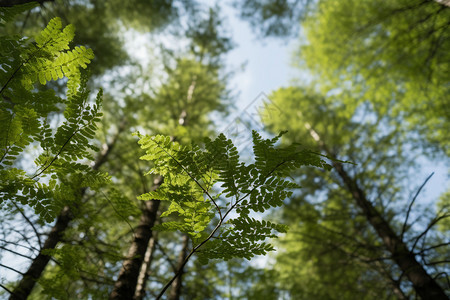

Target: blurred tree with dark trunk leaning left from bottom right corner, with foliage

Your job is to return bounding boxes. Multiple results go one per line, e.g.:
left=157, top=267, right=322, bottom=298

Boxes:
left=266, top=88, right=449, bottom=299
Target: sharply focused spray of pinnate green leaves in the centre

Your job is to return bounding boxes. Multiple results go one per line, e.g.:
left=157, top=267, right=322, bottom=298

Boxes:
left=137, top=131, right=329, bottom=262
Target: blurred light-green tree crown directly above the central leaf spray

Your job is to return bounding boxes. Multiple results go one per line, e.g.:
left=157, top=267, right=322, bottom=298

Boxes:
left=142, top=55, right=229, bottom=142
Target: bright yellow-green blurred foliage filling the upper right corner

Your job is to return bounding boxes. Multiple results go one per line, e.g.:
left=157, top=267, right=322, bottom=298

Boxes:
left=296, top=0, right=450, bottom=154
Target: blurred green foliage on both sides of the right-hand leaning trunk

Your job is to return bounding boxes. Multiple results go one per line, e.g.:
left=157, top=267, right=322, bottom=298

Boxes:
left=258, top=82, right=448, bottom=299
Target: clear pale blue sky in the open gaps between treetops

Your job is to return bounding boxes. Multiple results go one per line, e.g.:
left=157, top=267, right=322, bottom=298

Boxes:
left=2, top=1, right=449, bottom=288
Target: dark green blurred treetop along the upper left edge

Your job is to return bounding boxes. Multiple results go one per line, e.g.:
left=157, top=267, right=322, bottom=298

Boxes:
left=0, top=0, right=197, bottom=76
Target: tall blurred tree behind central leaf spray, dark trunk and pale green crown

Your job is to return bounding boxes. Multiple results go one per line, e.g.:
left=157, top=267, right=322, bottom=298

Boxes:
left=110, top=10, right=230, bottom=299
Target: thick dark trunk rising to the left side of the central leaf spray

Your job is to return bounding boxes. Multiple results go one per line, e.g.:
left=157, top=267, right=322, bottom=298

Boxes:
left=109, top=177, right=163, bottom=300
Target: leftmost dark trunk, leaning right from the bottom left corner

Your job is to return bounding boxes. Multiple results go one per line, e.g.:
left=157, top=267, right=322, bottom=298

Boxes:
left=9, top=120, right=126, bottom=300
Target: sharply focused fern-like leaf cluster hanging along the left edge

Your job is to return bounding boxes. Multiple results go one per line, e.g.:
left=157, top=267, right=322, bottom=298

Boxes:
left=0, top=5, right=107, bottom=222
